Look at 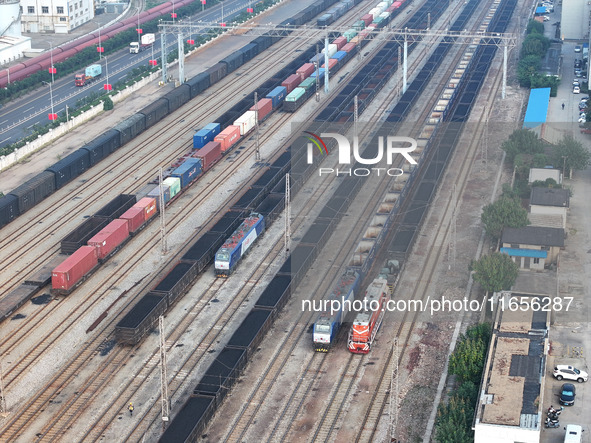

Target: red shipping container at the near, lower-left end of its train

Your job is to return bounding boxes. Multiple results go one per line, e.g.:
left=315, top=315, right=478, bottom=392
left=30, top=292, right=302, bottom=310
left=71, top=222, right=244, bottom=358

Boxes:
left=51, top=246, right=98, bottom=294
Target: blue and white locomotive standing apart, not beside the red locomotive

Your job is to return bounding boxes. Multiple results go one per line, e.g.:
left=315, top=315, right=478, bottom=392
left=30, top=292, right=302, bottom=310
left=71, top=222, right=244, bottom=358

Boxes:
left=215, top=212, right=265, bottom=277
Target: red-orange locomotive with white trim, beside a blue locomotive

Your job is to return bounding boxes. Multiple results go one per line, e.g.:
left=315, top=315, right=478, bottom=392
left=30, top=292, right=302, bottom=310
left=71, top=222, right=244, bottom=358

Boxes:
left=347, top=278, right=390, bottom=354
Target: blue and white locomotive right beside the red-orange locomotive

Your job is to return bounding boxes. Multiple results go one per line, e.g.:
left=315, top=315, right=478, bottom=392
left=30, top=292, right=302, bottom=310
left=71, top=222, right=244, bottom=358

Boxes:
left=312, top=268, right=362, bottom=352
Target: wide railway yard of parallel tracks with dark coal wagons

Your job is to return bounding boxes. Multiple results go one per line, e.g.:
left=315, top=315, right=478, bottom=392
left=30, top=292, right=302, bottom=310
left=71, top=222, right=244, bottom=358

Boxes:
left=0, top=0, right=568, bottom=442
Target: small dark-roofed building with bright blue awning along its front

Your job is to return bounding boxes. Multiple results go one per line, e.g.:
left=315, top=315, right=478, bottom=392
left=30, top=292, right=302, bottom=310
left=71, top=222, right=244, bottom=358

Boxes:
left=501, top=226, right=564, bottom=270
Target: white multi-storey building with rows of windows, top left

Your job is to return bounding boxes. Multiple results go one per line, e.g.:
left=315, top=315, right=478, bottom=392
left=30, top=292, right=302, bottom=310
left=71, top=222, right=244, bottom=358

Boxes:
left=20, top=0, right=94, bottom=34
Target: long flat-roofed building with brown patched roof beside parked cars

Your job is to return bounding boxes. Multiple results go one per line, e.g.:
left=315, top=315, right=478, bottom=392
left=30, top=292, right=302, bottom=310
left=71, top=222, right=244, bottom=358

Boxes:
left=473, top=294, right=548, bottom=443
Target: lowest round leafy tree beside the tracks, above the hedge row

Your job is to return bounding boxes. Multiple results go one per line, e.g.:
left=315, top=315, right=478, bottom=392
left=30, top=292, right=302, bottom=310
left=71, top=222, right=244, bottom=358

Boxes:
left=472, top=252, right=519, bottom=292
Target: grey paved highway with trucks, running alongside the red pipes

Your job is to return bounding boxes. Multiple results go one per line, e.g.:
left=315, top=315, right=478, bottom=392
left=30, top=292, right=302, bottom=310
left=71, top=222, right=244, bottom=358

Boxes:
left=0, top=0, right=248, bottom=147
